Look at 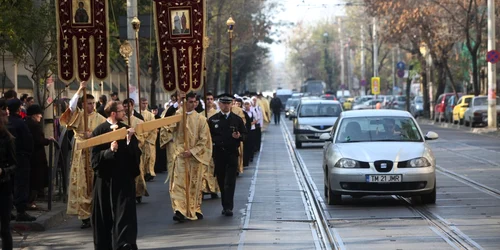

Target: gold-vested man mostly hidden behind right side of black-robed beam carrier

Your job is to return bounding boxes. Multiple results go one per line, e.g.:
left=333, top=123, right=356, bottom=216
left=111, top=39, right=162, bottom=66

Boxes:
left=122, top=98, right=149, bottom=203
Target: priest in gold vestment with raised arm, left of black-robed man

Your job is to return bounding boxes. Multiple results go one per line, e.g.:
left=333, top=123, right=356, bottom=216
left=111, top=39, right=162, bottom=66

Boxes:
left=60, top=82, right=106, bottom=229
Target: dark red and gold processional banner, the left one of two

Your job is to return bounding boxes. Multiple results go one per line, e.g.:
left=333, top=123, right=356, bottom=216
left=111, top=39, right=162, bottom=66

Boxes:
left=56, top=0, right=109, bottom=83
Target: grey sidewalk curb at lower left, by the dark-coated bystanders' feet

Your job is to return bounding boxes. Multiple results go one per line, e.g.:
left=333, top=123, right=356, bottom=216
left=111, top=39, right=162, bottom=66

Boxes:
left=10, top=203, right=67, bottom=232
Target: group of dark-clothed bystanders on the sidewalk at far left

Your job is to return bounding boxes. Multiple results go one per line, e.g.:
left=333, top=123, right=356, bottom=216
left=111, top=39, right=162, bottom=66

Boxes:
left=0, top=90, right=54, bottom=249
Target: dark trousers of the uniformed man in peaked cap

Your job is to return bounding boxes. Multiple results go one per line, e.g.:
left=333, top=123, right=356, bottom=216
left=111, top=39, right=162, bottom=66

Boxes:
left=214, top=153, right=238, bottom=210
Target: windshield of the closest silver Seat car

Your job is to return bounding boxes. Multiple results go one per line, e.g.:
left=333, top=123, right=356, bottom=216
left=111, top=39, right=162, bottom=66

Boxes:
left=336, top=116, right=422, bottom=143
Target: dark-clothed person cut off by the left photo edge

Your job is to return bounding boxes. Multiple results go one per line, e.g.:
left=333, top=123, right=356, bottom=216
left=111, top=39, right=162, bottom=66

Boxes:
left=0, top=99, right=17, bottom=250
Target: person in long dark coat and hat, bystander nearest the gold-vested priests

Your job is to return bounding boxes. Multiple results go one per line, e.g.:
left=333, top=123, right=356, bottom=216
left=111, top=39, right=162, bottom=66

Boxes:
left=26, top=105, right=54, bottom=209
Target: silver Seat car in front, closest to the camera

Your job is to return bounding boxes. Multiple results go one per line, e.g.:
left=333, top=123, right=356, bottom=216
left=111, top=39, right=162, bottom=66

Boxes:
left=320, top=110, right=438, bottom=205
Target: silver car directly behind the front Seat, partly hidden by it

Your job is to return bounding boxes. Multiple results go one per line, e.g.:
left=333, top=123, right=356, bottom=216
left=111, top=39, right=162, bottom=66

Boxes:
left=293, top=99, right=342, bottom=148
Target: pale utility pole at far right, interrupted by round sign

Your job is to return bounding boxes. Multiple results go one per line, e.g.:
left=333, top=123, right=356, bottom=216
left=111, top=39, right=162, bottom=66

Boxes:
left=488, top=0, right=497, bottom=129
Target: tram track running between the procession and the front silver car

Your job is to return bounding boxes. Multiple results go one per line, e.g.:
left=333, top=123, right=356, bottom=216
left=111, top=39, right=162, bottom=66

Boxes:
left=281, top=124, right=346, bottom=250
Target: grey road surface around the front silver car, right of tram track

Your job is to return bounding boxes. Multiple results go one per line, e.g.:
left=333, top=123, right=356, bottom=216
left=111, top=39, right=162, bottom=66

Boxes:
left=286, top=116, right=500, bottom=249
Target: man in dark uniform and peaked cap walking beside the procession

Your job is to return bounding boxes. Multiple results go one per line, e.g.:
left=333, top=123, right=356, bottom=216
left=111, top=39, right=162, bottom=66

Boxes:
left=208, top=94, right=247, bottom=216
